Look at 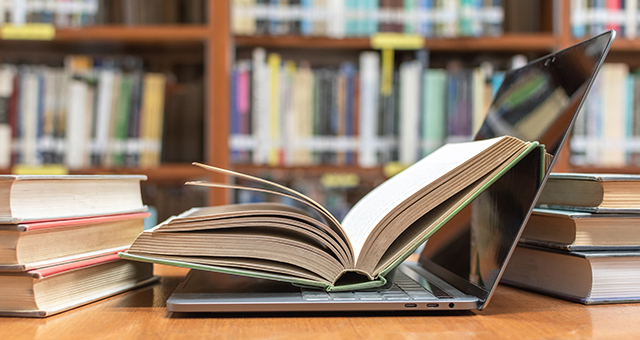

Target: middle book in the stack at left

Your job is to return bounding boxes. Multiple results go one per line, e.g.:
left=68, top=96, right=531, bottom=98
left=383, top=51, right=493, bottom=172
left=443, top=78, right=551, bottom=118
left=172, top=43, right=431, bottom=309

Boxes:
left=0, top=212, right=149, bottom=271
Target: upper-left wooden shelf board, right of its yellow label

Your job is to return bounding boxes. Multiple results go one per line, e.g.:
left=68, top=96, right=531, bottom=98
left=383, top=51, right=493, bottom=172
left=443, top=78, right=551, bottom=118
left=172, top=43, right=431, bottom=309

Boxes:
left=54, top=25, right=209, bottom=43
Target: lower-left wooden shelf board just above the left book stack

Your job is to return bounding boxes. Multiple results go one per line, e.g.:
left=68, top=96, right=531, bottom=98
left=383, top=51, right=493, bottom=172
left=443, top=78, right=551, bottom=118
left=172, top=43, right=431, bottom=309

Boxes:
left=0, top=164, right=209, bottom=182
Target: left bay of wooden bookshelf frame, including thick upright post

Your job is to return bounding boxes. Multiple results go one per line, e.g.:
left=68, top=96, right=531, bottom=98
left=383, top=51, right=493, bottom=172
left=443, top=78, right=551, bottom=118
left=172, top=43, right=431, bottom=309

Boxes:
left=0, top=1, right=231, bottom=204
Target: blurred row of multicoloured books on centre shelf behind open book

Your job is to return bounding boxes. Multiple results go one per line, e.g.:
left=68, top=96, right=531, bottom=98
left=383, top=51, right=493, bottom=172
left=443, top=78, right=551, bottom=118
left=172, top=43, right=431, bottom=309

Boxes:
left=229, top=48, right=504, bottom=167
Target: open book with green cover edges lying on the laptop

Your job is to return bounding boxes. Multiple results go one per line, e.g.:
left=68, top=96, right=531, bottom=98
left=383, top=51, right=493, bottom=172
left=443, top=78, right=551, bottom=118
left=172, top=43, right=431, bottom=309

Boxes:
left=120, top=136, right=544, bottom=291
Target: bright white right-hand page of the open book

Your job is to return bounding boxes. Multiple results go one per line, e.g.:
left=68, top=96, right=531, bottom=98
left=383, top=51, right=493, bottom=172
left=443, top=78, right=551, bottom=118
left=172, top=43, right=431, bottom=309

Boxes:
left=342, top=137, right=505, bottom=259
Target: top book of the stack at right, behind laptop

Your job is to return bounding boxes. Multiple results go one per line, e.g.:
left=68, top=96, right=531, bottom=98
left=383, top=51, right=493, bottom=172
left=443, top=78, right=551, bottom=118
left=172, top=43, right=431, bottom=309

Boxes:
left=538, top=173, right=640, bottom=213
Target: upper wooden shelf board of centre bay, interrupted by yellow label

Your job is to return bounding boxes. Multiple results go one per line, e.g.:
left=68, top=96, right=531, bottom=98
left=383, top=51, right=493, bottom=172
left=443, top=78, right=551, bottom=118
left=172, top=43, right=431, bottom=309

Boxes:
left=235, top=34, right=556, bottom=52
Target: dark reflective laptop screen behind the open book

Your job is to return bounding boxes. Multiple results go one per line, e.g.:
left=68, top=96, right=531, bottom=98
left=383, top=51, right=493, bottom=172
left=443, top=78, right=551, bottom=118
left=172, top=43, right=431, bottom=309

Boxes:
left=420, top=31, right=615, bottom=308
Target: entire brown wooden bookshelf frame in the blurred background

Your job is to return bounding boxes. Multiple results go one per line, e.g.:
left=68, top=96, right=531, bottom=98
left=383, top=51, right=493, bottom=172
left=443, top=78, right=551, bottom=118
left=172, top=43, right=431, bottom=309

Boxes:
left=0, top=0, right=640, bottom=210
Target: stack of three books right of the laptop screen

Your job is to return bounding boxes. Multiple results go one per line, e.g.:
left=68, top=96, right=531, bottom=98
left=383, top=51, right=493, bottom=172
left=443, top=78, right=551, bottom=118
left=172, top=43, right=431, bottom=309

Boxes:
left=502, top=174, right=640, bottom=304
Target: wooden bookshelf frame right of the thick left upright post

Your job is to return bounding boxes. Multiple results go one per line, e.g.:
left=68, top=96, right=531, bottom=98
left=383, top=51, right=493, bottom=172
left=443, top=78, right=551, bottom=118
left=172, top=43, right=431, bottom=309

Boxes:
left=228, top=0, right=640, bottom=189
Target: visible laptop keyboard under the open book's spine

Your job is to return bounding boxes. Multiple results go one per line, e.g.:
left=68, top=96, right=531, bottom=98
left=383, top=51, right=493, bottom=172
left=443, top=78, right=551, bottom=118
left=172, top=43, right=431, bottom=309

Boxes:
left=302, top=271, right=453, bottom=301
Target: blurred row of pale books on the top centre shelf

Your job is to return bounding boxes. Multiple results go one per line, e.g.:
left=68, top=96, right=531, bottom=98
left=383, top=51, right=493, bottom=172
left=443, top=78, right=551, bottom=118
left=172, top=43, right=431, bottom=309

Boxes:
left=231, top=0, right=505, bottom=38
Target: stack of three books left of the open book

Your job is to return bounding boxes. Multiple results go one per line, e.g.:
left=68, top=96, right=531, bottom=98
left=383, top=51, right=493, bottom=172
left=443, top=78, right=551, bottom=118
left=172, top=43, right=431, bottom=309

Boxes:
left=0, top=175, right=154, bottom=317
